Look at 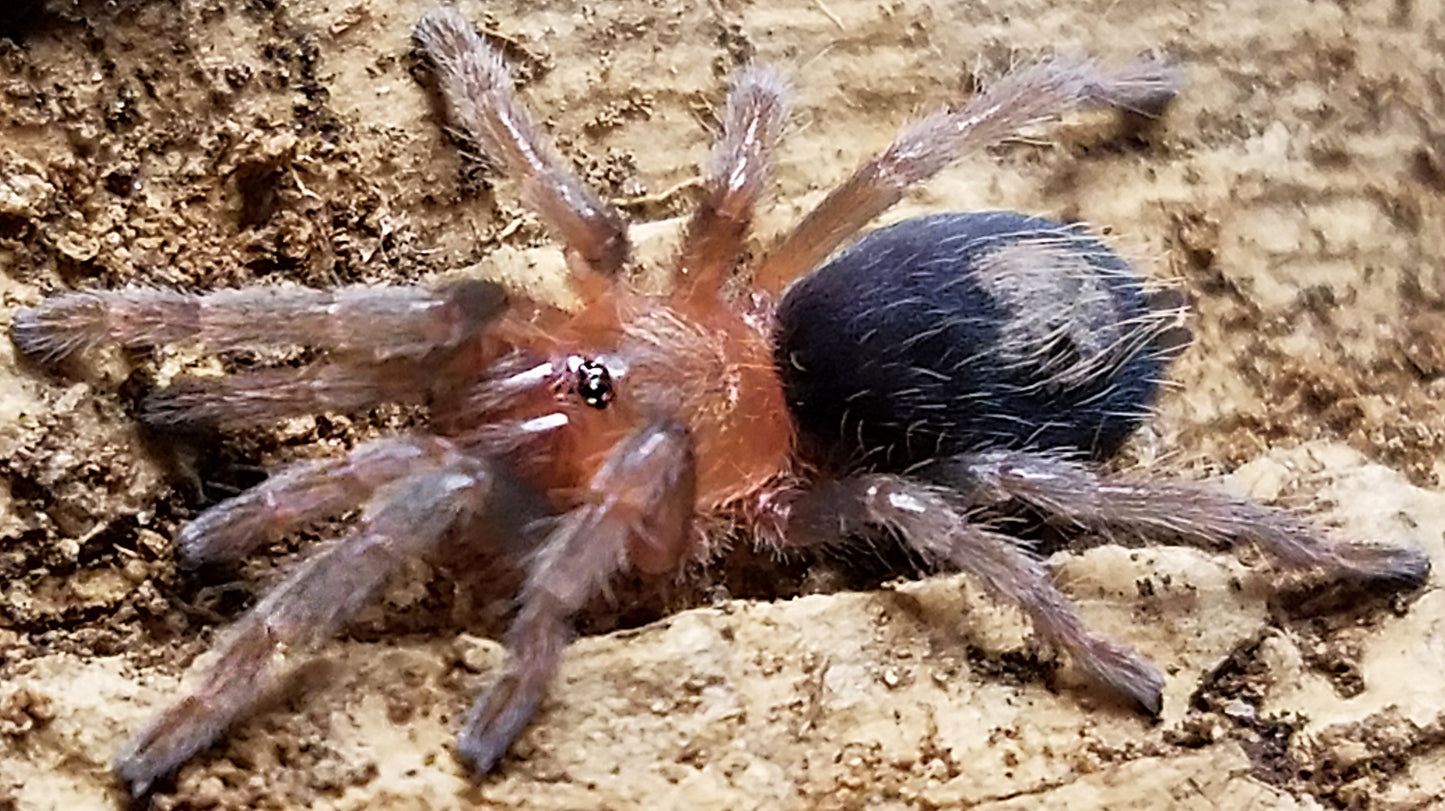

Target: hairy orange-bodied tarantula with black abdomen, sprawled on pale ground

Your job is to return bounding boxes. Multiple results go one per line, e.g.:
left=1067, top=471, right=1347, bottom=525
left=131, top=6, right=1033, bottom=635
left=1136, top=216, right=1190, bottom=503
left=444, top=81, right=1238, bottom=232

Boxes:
left=13, top=7, right=1429, bottom=795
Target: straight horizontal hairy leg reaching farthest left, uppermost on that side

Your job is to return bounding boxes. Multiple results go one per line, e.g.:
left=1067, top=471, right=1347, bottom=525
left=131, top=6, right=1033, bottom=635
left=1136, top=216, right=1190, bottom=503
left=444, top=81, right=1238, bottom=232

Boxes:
left=10, top=282, right=506, bottom=361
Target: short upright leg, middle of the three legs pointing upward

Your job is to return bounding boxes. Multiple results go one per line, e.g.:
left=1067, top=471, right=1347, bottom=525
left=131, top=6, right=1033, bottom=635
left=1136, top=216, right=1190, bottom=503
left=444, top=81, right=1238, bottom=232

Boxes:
left=678, top=66, right=788, bottom=296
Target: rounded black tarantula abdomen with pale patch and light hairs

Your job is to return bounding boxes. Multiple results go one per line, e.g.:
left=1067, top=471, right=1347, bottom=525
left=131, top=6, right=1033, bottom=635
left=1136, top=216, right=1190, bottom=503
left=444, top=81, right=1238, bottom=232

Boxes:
left=775, top=213, right=1173, bottom=470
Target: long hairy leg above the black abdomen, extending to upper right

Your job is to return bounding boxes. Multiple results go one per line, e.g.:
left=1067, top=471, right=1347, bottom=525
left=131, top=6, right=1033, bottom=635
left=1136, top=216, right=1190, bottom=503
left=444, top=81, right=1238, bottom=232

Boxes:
left=753, top=59, right=1182, bottom=295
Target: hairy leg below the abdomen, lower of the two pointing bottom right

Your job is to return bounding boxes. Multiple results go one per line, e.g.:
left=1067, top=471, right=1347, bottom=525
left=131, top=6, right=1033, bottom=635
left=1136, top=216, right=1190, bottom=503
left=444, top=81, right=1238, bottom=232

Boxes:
left=788, top=474, right=1163, bottom=714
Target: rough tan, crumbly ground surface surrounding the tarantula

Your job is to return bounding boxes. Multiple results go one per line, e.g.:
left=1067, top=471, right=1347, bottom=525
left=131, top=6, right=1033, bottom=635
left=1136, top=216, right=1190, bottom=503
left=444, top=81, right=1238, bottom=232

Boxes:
left=0, top=0, right=1445, bottom=811
